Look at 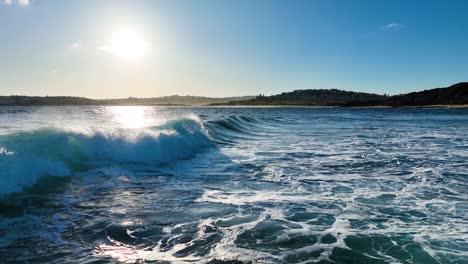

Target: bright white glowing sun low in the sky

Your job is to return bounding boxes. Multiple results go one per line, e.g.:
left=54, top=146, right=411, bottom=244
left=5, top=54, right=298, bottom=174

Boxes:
left=103, top=27, right=147, bottom=61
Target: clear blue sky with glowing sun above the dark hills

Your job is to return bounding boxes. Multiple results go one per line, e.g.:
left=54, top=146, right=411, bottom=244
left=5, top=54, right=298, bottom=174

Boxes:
left=0, top=0, right=468, bottom=98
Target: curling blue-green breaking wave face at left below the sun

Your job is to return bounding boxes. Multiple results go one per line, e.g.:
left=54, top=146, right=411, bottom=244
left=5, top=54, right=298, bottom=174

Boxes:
left=0, top=116, right=212, bottom=194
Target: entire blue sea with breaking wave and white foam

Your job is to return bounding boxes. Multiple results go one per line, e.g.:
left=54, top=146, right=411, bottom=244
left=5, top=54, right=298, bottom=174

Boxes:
left=0, top=107, right=468, bottom=264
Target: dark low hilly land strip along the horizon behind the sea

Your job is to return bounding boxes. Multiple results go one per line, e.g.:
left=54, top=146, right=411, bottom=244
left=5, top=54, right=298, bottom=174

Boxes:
left=0, top=82, right=468, bottom=107
